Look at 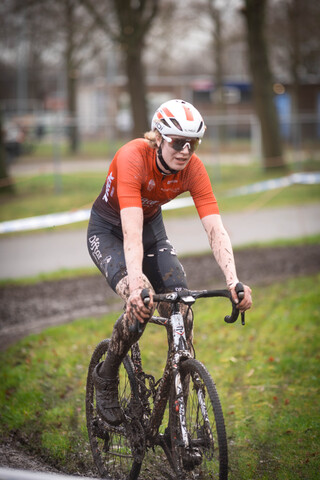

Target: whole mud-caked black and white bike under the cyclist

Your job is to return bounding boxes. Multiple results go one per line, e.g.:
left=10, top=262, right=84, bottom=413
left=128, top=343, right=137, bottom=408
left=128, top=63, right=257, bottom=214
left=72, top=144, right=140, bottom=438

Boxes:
left=86, top=284, right=244, bottom=479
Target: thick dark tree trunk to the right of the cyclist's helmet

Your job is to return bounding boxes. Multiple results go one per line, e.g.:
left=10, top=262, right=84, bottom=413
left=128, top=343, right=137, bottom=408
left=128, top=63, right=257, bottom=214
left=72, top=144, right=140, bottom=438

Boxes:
left=243, top=0, right=285, bottom=169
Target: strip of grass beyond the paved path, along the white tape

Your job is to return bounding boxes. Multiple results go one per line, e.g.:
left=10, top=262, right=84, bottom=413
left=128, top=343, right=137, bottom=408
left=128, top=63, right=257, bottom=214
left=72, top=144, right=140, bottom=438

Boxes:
left=0, top=158, right=320, bottom=227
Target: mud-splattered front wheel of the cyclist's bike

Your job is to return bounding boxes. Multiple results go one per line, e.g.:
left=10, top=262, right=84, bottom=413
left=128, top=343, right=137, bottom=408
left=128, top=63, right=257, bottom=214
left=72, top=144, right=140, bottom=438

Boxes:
left=170, top=359, right=228, bottom=480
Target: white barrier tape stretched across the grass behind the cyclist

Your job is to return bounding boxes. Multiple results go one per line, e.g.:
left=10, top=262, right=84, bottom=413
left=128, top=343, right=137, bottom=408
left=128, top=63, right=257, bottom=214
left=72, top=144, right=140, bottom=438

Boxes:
left=0, top=172, right=320, bottom=234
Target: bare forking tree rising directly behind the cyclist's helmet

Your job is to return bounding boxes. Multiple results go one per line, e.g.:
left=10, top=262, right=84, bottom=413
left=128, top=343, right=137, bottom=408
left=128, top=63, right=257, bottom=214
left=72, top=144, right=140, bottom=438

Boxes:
left=80, top=0, right=159, bottom=137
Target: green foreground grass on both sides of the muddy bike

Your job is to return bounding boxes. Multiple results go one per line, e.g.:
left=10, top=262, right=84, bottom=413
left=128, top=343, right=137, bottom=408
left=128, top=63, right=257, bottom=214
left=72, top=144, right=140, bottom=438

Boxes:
left=0, top=275, right=320, bottom=480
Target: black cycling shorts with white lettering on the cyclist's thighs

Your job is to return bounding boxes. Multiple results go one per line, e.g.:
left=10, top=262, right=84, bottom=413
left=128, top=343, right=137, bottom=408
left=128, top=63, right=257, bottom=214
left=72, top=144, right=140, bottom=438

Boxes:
left=87, top=209, right=187, bottom=293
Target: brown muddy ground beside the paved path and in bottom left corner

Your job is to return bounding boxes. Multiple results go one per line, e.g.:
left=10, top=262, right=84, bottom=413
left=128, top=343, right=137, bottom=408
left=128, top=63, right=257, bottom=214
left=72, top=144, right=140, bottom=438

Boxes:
left=0, top=245, right=320, bottom=475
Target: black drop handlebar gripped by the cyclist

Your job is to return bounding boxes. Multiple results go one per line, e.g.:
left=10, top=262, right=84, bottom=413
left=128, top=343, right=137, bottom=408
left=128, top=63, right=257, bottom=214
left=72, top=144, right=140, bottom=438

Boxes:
left=129, top=282, right=245, bottom=333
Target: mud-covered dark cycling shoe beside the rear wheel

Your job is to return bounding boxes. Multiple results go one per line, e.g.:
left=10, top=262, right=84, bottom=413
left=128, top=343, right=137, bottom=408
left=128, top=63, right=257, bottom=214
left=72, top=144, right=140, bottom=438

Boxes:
left=93, top=362, right=124, bottom=426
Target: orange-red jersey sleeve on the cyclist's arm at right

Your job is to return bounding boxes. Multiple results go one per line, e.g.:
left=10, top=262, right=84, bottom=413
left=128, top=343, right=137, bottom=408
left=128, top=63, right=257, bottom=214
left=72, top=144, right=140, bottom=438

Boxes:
left=188, top=155, right=219, bottom=218
